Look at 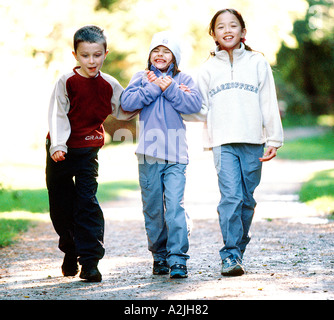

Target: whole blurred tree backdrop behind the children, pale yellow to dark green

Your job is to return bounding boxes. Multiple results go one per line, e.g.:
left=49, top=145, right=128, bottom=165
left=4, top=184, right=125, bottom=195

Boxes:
left=0, top=0, right=334, bottom=165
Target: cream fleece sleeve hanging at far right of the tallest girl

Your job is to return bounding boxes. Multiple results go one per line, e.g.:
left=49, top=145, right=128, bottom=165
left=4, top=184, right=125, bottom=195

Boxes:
left=259, top=61, right=283, bottom=149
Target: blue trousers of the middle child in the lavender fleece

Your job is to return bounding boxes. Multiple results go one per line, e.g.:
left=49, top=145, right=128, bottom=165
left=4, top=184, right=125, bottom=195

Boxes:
left=138, top=155, right=190, bottom=267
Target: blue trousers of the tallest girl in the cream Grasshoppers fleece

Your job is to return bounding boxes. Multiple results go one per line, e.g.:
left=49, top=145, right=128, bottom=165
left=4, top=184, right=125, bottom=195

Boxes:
left=213, top=143, right=264, bottom=260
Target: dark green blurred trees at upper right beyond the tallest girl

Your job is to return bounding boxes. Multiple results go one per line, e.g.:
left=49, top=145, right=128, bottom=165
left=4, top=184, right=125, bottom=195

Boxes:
left=275, top=0, right=334, bottom=115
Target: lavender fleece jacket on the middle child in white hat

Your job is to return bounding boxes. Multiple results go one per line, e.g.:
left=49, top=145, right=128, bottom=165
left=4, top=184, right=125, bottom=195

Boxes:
left=121, top=64, right=202, bottom=164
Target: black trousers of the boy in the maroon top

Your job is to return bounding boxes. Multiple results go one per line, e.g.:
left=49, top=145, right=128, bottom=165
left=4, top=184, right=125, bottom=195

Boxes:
left=46, top=141, right=105, bottom=265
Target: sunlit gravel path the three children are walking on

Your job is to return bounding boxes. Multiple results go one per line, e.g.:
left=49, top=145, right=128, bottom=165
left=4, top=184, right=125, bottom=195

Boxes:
left=0, top=125, right=334, bottom=301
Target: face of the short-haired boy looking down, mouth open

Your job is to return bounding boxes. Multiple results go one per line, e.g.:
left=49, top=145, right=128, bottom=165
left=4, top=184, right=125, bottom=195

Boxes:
left=73, top=41, right=108, bottom=78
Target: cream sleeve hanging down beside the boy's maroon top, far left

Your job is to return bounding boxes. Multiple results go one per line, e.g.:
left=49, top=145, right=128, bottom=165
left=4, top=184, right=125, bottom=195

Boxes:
left=48, top=76, right=71, bottom=161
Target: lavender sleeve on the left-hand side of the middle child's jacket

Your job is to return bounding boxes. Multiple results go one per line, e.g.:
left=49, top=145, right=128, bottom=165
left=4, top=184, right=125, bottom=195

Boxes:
left=121, top=71, right=162, bottom=111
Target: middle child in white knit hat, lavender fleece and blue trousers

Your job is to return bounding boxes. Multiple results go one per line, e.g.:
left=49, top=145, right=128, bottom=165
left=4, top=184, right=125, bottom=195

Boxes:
left=121, top=31, right=202, bottom=278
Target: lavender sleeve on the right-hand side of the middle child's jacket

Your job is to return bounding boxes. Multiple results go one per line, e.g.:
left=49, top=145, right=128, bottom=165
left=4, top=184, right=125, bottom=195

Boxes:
left=163, top=74, right=202, bottom=114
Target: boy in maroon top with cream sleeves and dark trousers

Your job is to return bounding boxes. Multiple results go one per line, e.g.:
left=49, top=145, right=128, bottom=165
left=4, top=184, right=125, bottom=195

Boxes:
left=46, top=26, right=135, bottom=282
